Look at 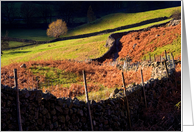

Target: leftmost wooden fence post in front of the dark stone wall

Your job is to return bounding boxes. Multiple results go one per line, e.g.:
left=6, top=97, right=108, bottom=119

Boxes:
left=13, top=69, right=22, bottom=131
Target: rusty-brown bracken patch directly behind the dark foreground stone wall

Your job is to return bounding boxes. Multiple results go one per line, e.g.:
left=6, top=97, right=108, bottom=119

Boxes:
left=1, top=60, right=152, bottom=97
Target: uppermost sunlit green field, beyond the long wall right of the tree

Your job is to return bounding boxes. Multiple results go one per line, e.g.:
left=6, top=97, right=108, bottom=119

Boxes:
left=66, top=7, right=181, bottom=36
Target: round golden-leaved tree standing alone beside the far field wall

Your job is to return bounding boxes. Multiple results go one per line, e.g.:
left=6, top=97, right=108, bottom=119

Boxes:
left=47, top=19, right=68, bottom=38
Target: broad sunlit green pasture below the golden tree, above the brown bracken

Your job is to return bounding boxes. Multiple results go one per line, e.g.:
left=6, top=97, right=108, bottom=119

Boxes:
left=1, top=34, right=109, bottom=66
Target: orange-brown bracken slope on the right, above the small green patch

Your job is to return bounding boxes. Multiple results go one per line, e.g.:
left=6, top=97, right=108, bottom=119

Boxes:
left=119, top=23, right=181, bottom=62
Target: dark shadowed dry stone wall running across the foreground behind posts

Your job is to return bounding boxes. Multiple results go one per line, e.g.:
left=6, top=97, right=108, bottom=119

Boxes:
left=1, top=59, right=176, bottom=131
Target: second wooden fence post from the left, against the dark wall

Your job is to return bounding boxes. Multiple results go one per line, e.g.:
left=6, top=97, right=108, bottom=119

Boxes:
left=82, top=70, right=93, bottom=131
